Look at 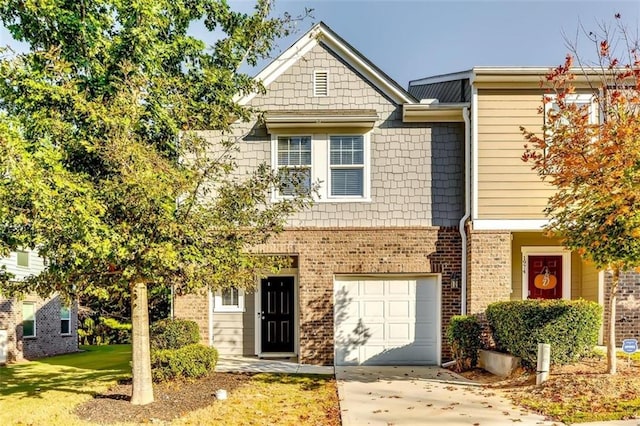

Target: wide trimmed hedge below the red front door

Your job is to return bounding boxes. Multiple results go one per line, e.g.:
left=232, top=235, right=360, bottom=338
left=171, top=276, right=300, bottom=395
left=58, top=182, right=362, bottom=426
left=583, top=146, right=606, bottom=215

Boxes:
left=487, top=300, right=602, bottom=367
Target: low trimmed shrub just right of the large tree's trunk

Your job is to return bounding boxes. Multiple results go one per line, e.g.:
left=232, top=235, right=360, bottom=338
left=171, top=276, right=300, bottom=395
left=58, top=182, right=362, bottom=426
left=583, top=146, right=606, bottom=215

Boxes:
left=151, top=344, right=218, bottom=382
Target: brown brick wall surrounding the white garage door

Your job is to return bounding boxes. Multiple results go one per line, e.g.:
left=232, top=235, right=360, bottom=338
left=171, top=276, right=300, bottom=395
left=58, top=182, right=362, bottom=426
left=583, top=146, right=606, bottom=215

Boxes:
left=174, top=227, right=461, bottom=365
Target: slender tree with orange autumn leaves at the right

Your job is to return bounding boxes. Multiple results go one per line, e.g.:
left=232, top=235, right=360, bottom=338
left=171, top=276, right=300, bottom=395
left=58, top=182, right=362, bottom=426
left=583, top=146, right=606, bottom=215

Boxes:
left=521, top=15, right=640, bottom=374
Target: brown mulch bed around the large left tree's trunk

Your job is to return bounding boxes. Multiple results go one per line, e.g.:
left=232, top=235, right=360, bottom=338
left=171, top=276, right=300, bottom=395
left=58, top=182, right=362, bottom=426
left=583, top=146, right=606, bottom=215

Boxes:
left=75, top=373, right=253, bottom=424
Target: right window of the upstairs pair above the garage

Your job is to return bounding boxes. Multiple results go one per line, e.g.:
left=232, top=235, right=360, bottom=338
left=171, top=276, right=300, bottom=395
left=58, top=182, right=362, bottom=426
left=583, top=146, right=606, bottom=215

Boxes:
left=329, top=136, right=364, bottom=197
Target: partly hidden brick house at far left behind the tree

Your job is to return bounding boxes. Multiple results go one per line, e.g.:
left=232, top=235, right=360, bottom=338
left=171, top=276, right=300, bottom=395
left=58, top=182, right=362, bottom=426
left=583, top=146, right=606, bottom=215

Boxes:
left=0, top=251, right=78, bottom=364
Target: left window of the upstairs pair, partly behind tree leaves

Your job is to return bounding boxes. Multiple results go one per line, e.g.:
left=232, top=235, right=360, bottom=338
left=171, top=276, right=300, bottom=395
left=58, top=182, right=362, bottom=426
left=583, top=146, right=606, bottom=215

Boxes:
left=277, top=136, right=311, bottom=196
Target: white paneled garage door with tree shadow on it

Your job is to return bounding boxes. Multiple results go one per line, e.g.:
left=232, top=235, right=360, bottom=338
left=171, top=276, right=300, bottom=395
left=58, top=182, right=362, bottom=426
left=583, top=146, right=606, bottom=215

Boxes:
left=334, top=277, right=440, bottom=365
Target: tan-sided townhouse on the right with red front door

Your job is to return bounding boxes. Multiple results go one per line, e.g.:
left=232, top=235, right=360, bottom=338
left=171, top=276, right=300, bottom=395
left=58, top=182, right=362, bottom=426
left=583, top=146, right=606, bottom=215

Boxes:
left=409, top=67, right=640, bottom=344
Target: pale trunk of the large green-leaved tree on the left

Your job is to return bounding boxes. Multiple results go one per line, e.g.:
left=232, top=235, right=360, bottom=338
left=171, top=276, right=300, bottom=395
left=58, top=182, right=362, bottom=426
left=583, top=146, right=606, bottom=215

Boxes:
left=131, top=279, right=153, bottom=405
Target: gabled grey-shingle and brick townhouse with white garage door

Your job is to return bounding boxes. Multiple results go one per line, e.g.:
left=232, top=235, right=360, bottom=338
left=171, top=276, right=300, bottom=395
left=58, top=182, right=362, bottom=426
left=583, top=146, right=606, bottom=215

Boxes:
left=174, top=23, right=468, bottom=365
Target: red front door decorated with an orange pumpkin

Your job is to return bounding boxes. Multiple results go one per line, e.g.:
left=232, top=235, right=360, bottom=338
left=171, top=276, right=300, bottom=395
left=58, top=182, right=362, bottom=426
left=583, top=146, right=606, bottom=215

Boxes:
left=528, top=256, right=562, bottom=299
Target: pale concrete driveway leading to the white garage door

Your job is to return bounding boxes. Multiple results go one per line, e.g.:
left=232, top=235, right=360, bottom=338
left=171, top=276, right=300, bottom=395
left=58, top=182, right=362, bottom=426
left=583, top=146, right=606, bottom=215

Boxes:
left=336, top=366, right=561, bottom=426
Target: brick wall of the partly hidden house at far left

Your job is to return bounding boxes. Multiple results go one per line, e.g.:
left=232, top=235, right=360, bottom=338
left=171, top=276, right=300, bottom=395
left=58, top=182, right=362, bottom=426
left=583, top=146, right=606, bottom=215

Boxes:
left=0, top=295, right=78, bottom=362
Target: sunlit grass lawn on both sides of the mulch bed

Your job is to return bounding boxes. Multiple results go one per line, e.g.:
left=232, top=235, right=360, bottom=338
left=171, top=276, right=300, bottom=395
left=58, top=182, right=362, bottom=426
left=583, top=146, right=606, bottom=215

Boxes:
left=0, top=345, right=340, bottom=426
